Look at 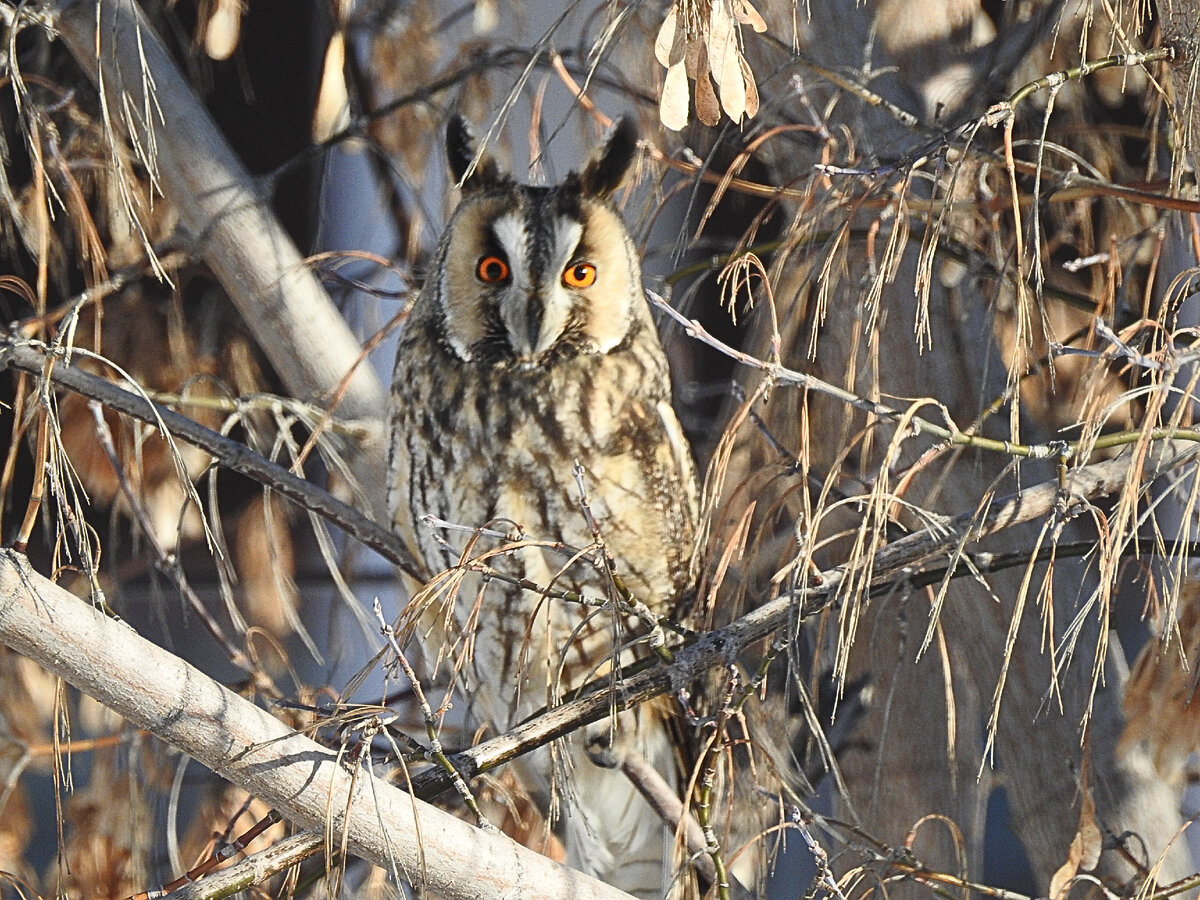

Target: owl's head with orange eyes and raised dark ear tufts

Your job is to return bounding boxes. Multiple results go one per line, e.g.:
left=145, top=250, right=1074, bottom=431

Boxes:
left=427, top=116, right=649, bottom=368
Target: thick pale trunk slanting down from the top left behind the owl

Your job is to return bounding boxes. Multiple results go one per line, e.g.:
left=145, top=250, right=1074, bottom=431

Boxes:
left=42, top=0, right=386, bottom=514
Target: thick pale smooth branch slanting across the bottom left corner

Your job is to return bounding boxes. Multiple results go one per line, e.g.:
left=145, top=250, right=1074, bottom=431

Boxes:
left=0, top=550, right=628, bottom=900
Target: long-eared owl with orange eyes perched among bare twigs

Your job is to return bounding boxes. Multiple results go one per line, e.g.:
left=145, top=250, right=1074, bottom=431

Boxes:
left=389, top=121, right=697, bottom=896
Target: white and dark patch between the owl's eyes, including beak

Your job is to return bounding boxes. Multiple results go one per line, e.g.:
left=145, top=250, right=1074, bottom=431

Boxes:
left=492, top=212, right=583, bottom=366
